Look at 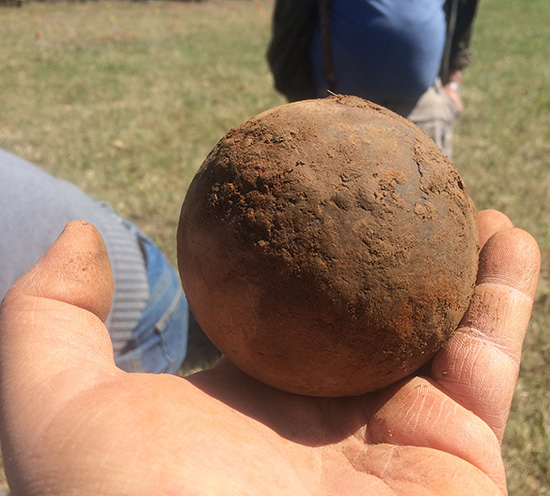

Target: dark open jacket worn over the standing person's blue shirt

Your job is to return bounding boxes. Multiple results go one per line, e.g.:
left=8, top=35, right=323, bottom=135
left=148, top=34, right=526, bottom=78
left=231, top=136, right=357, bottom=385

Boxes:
left=267, top=0, right=478, bottom=101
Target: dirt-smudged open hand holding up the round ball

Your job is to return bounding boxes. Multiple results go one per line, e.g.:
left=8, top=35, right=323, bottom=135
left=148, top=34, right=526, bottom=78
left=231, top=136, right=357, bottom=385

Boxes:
left=0, top=211, right=540, bottom=496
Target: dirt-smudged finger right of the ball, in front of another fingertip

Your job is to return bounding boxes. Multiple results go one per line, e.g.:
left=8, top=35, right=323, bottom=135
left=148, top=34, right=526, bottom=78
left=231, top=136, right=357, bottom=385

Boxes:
left=432, top=222, right=540, bottom=440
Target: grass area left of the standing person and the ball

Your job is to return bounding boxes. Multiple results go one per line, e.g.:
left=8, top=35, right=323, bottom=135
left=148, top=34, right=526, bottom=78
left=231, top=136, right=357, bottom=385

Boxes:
left=0, top=1, right=283, bottom=260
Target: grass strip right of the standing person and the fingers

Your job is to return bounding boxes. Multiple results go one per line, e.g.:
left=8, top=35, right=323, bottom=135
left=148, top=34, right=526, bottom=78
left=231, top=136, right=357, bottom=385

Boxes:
left=455, top=0, right=550, bottom=496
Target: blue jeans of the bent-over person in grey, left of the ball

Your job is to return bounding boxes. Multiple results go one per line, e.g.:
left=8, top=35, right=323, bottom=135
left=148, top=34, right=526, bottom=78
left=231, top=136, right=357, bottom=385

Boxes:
left=115, top=231, right=189, bottom=374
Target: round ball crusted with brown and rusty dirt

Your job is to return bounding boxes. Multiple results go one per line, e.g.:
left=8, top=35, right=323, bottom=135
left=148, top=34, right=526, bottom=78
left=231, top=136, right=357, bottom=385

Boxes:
left=178, top=96, right=479, bottom=396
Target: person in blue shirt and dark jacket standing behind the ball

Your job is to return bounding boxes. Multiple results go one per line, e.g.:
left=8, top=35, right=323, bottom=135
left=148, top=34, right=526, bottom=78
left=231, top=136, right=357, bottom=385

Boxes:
left=268, top=0, right=478, bottom=157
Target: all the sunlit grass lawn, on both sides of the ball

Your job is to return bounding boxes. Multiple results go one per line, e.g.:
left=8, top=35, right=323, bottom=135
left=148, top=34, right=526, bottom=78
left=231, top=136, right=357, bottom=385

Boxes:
left=0, top=0, right=550, bottom=496
